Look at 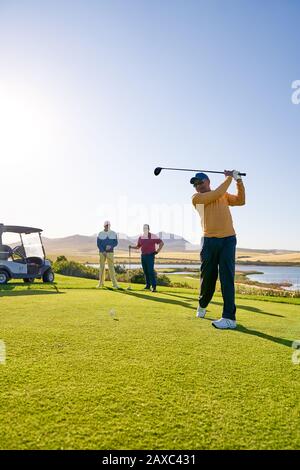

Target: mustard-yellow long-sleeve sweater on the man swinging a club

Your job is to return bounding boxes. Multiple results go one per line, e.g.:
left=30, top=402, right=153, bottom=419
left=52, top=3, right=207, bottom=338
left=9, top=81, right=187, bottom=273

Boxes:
left=192, top=176, right=245, bottom=238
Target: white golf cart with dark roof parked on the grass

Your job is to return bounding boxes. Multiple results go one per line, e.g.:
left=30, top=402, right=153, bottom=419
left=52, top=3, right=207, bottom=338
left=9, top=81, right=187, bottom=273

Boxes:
left=0, top=224, right=54, bottom=285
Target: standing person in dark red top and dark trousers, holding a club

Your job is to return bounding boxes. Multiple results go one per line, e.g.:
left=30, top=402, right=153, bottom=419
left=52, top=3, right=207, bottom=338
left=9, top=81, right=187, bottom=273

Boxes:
left=129, top=224, right=164, bottom=292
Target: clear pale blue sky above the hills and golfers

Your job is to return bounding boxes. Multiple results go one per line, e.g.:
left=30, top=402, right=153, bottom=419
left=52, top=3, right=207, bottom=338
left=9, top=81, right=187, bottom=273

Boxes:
left=0, top=0, right=300, bottom=250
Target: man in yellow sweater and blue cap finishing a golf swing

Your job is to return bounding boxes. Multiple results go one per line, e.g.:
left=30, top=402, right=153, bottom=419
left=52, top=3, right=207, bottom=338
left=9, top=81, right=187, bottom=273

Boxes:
left=190, top=170, right=245, bottom=329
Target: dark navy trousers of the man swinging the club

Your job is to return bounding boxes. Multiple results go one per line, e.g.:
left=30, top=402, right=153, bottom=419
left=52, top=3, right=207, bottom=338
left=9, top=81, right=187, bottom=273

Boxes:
left=199, top=235, right=236, bottom=320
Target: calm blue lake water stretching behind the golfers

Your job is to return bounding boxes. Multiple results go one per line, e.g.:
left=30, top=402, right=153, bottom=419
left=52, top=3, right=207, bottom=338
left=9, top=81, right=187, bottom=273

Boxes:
left=90, top=264, right=300, bottom=290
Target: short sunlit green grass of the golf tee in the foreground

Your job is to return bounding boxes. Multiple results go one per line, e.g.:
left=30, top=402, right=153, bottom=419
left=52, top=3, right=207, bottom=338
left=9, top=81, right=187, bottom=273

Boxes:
left=0, top=276, right=300, bottom=449
